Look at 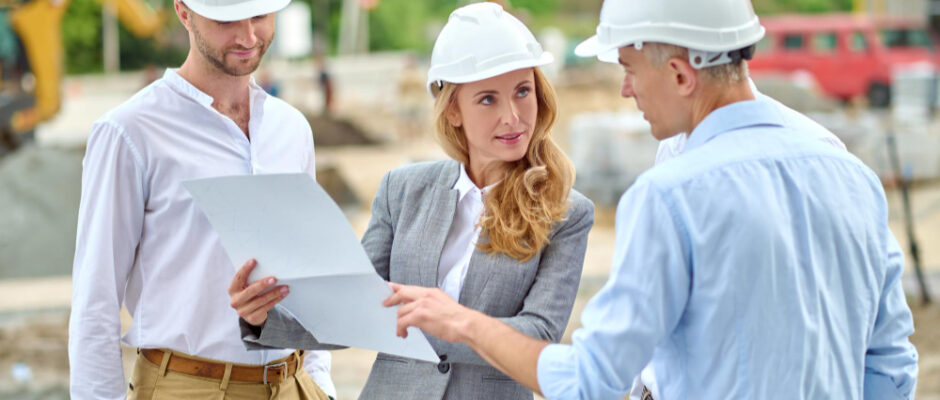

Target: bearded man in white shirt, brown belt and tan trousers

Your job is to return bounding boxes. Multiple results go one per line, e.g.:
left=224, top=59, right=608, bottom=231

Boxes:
left=69, top=0, right=334, bottom=399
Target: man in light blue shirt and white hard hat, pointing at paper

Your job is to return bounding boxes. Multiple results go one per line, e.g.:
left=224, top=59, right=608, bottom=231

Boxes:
left=386, top=0, right=917, bottom=399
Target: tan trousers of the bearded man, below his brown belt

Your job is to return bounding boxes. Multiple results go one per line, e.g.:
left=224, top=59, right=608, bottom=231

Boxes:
left=127, top=354, right=329, bottom=400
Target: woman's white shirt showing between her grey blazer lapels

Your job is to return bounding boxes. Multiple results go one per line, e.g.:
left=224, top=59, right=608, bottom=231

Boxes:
left=437, top=166, right=495, bottom=301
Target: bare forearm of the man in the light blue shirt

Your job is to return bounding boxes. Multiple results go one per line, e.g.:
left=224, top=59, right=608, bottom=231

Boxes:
left=461, top=311, right=548, bottom=394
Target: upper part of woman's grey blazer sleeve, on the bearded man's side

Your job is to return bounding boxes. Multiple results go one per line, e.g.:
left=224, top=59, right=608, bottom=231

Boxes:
left=362, top=172, right=395, bottom=281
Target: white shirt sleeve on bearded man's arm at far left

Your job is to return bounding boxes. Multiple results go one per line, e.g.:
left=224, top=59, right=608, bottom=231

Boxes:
left=69, top=123, right=146, bottom=399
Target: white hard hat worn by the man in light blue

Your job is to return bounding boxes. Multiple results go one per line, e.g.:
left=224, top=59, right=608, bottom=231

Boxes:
left=575, top=0, right=764, bottom=68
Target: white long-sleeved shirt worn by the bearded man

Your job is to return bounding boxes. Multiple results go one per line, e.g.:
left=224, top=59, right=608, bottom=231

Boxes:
left=69, top=70, right=335, bottom=400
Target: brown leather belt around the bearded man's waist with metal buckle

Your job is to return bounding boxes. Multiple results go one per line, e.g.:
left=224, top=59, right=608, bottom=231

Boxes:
left=140, top=349, right=304, bottom=384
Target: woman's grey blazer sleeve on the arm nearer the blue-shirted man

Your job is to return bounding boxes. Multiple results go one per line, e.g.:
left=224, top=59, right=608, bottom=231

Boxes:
left=425, top=196, right=594, bottom=366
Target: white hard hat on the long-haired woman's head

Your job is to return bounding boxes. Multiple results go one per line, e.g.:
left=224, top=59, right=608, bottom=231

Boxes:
left=427, top=3, right=554, bottom=96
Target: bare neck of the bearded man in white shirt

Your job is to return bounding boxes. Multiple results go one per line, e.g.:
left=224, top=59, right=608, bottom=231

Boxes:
left=177, top=49, right=251, bottom=109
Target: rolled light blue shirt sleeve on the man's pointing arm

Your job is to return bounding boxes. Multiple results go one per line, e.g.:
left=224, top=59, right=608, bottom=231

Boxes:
left=537, top=180, right=691, bottom=400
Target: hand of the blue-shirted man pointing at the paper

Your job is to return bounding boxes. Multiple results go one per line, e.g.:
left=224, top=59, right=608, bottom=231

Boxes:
left=382, top=282, right=479, bottom=342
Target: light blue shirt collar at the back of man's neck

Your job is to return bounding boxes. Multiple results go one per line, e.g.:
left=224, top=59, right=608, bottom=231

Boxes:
left=683, top=100, right=784, bottom=152
